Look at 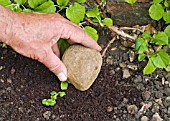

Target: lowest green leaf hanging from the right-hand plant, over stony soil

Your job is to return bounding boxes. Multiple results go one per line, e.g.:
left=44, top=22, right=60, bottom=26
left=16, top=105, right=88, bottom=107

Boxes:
left=143, top=57, right=156, bottom=74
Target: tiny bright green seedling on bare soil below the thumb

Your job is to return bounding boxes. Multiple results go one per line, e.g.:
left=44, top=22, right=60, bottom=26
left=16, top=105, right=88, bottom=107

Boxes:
left=41, top=82, right=68, bottom=106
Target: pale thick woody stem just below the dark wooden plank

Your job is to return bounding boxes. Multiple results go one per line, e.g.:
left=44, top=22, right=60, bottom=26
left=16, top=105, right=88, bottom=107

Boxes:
left=109, top=26, right=137, bottom=41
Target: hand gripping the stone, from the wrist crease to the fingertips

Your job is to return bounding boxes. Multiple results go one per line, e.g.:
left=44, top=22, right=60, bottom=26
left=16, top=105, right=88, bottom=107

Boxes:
left=5, top=11, right=101, bottom=81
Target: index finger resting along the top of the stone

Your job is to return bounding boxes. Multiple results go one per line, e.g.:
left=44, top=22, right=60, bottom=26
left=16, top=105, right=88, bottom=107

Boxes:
left=61, top=21, right=101, bottom=51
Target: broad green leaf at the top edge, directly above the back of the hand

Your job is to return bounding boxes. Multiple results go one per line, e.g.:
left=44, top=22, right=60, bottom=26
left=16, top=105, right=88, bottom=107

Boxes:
left=34, top=0, right=56, bottom=13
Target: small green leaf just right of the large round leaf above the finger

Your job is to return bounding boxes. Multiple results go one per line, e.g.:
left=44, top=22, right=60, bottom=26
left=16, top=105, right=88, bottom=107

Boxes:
left=86, top=5, right=100, bottom=17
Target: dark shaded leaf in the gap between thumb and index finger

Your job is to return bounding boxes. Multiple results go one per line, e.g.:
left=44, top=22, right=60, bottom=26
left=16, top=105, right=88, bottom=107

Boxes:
left=57, top=39, right=70, bottom=56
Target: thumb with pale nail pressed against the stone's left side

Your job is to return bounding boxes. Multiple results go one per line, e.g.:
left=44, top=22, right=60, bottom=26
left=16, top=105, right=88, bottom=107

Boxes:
left=41, top=49, right=67, bottom=81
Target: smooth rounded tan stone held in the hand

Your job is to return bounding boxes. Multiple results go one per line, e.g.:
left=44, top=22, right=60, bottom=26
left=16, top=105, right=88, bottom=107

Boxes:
left=62, top=45, right=102, bottom=91
